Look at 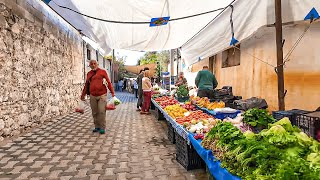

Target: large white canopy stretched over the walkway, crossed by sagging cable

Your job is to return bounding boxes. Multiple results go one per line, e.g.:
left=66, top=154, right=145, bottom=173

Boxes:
left=49, top=0, right=232, bottom=53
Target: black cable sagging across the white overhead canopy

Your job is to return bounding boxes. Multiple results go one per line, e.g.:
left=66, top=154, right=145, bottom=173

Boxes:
left=52, top=0, right=224, bottom=24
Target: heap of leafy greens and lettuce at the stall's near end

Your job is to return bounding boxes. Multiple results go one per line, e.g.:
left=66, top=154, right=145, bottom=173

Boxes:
left=201, top=118, right=320, bottom=180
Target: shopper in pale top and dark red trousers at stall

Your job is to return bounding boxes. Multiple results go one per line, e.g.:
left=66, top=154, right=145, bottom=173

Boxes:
left=140, top=70, right=152, bottom=114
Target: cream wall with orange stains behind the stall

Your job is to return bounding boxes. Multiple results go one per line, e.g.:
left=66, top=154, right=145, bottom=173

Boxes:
left=215, top=22, right=320, bottom=110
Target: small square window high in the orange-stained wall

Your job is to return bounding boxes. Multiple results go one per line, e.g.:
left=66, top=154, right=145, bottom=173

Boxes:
left=222, top=45, right=240, bottom=68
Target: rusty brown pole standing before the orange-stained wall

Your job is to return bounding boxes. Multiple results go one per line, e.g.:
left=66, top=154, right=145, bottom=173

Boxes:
left=275, top=0, right=285, bottom=111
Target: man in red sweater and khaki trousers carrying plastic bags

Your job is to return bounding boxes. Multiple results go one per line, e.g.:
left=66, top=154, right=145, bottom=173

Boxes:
left=81, top=60, right=114, bottom=134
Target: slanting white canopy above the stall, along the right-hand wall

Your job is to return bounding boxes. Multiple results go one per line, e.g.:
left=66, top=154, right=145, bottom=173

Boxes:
left=181, top=0, right=320, bottom=65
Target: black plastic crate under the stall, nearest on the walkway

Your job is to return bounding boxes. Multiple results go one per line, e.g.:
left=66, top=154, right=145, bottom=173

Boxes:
left=175, top=133, right=205, bottom=171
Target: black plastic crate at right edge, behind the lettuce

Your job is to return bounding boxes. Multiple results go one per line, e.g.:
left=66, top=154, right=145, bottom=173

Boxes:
left=296, top=111, right=320, bottom=139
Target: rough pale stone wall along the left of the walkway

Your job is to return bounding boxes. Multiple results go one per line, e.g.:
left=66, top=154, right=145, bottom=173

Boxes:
left=0, top=0, right=84, bottom=141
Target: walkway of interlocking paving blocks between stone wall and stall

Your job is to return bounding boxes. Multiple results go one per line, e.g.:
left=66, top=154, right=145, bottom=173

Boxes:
left=0, top=93, right=206, bottom=180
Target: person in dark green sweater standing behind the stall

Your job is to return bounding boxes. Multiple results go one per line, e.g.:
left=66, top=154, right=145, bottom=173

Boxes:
left=195, top=66, right=218, bottom=99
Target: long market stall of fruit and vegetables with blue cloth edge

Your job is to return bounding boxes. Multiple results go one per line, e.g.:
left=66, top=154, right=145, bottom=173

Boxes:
left=152, top=95, right=320, bottom=180
